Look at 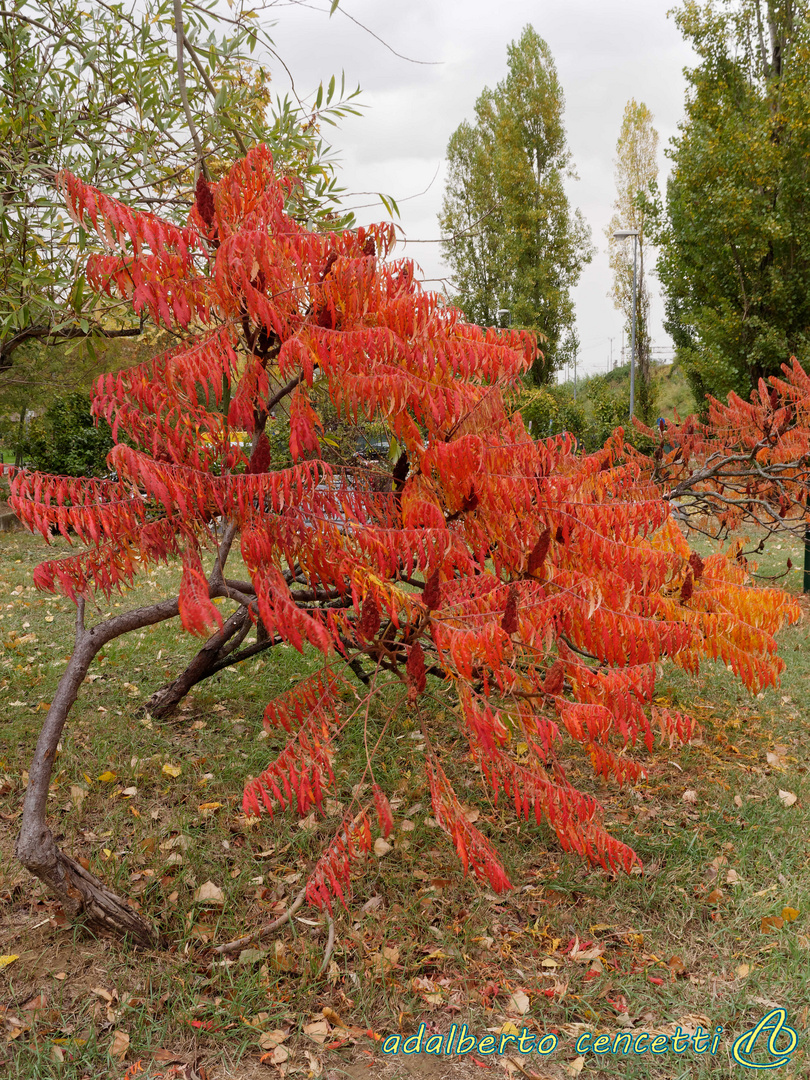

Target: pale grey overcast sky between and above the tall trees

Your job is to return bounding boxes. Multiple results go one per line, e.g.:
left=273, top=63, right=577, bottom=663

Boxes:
left=270, top=0, right=694, bottom=373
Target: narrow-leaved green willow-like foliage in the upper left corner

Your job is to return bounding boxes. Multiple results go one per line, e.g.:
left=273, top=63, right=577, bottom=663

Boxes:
left=0, top=0, right=357, bottom=386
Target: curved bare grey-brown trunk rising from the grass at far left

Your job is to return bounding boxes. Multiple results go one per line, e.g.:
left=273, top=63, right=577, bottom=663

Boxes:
left=16, top=600, right=177, bottom=946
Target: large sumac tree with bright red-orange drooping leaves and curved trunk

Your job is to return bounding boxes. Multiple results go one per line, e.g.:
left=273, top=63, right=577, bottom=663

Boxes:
left=3, top=147, right=794, bottom=942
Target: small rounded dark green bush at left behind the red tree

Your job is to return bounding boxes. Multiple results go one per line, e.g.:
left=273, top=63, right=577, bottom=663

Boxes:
left=24, top=393, right=112, bottom=476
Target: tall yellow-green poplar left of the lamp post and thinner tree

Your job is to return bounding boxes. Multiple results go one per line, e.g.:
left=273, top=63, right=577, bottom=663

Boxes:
left=440, top=26, right=592, bottom=383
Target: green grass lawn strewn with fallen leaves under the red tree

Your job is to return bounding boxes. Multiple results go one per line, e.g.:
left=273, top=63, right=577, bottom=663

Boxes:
left=0, top=535, right=810, bottom=1080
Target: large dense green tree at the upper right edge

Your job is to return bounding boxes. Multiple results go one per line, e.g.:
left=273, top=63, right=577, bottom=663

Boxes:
left=656, top=0, right=810, bottom=402
